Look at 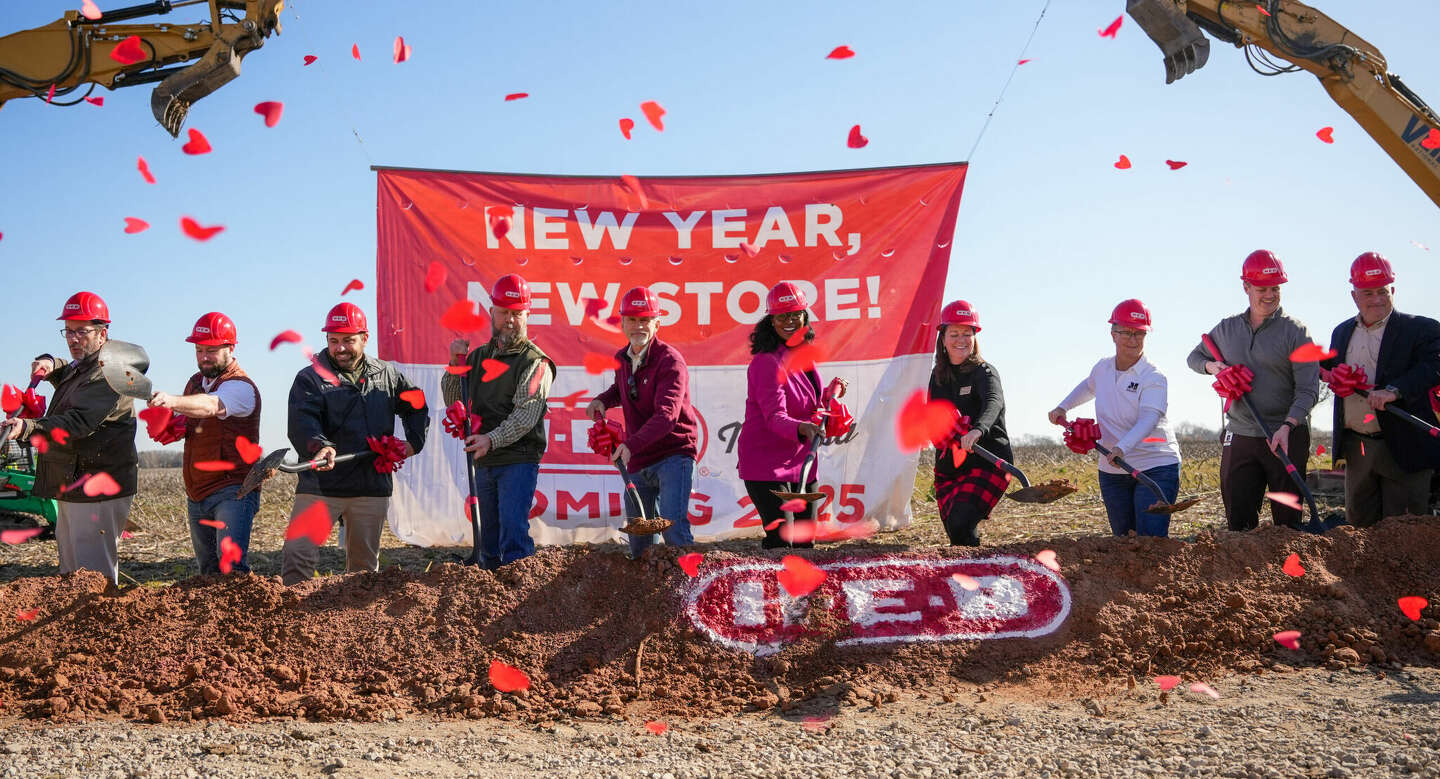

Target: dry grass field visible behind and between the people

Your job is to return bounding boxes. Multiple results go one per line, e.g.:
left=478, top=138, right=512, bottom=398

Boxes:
left=0, top=441, right=1342, bottom=586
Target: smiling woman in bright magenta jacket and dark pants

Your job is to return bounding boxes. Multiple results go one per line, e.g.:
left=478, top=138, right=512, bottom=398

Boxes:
left=739, top=281, right=824, bottom=549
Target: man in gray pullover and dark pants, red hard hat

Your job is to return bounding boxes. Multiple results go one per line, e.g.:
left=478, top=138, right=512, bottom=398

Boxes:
left=1187, top=249, right=1320, bottom=530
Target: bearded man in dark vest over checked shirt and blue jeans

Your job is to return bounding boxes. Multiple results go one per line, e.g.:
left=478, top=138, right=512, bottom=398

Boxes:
left=441, top=274, right=554, bottom=570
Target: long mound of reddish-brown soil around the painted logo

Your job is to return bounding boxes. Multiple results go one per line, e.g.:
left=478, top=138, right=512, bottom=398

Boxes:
left=0, top=517, right=1440, bottom=723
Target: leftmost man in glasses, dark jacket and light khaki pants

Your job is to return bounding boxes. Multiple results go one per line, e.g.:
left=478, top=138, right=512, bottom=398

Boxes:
left=0, top=292, right=140, bottom=585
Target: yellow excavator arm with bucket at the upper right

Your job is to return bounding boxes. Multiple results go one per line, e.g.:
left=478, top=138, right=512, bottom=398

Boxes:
left=1125, top=0, right=1440, bottom=206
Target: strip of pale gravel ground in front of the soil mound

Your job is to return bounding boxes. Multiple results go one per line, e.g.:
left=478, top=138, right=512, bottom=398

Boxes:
left=0, top=668, right=1440, bottom=779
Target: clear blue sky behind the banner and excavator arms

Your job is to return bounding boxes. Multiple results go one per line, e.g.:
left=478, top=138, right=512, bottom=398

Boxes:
left=0, top=0, right=1440, bottom=448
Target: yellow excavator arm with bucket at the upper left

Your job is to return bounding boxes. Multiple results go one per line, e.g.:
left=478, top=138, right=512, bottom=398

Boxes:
left=0, top=0, right=285, bottom=135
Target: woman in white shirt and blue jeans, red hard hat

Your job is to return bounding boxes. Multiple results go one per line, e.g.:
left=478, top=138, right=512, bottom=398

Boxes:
left=1050, top=300, right=1179, bottom=536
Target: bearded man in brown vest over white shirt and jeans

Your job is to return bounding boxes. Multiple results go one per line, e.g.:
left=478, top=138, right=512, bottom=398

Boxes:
left=150, top=311, right=261, bottom=576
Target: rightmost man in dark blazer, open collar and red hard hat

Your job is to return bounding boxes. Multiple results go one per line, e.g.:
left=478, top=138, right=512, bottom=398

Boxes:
left=1322, top=252, right=1440, bottom=527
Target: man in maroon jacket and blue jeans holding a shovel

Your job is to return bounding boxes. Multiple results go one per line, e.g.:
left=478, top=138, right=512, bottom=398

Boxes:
left=586, top=287, right=700, bottom=557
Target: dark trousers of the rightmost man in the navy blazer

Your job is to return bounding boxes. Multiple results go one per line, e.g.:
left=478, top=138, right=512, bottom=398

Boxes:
left=1345, top=432, right=1433, bottom=527
